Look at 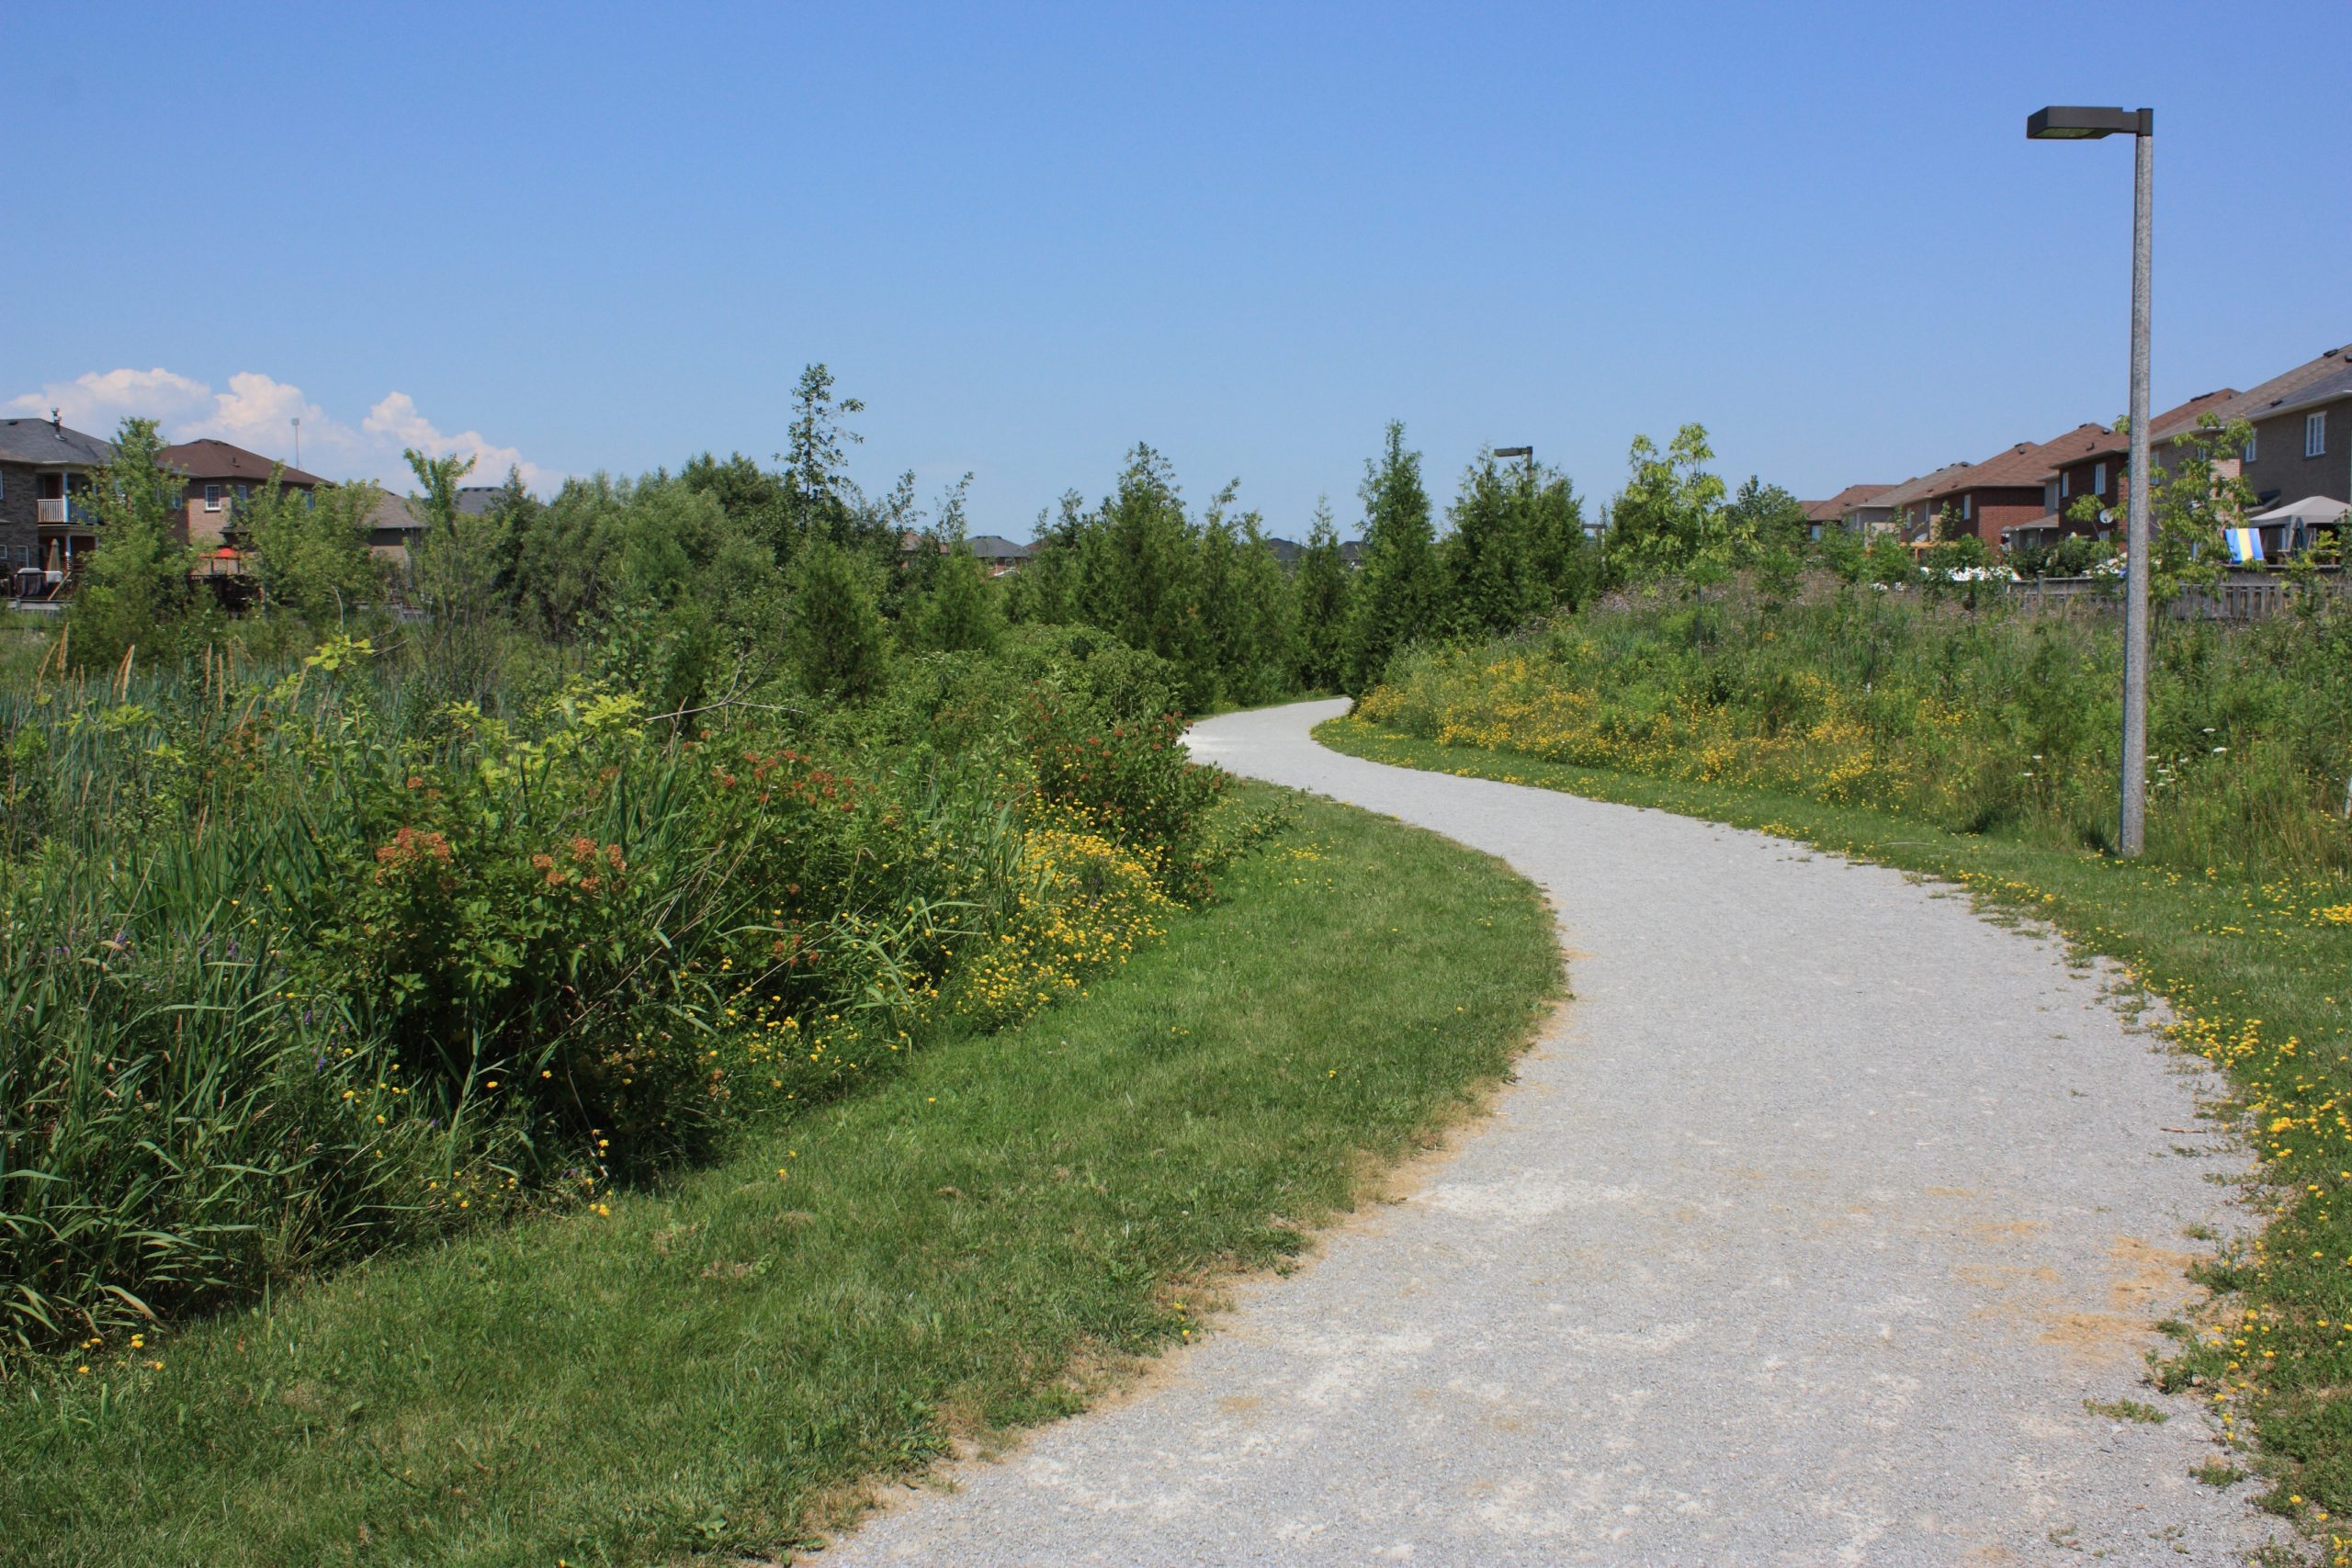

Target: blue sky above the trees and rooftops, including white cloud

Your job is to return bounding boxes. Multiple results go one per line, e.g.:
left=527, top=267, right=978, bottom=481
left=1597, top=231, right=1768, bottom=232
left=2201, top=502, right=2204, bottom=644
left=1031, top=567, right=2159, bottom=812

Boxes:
left=0, top=0, right=2352, bottom=538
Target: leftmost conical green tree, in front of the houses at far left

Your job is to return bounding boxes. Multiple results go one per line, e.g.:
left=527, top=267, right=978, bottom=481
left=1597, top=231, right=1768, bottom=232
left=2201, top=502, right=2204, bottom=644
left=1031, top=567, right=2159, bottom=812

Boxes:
left=66, top=419, right=190, bottom=668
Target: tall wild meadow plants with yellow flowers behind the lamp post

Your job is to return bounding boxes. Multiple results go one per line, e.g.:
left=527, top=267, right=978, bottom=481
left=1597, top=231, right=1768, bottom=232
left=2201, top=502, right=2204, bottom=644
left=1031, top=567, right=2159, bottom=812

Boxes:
left=1360, top=581, right=2352, bottom=879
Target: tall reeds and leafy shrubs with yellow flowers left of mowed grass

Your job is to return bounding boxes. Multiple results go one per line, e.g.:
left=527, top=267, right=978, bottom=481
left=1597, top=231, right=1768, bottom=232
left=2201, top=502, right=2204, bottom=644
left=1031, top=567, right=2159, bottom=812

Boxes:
left=0, top=632, right=1238, bottom=1347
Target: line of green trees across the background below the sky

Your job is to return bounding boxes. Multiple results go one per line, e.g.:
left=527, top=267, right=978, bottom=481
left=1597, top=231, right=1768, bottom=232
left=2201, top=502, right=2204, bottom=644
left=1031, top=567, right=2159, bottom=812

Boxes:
left=55, top=365, right=1844, bottom=712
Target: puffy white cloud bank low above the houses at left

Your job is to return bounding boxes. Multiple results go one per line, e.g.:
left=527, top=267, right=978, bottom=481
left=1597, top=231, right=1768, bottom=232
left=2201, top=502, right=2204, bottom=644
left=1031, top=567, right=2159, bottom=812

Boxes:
left=0, top=367, right=564, bottom=491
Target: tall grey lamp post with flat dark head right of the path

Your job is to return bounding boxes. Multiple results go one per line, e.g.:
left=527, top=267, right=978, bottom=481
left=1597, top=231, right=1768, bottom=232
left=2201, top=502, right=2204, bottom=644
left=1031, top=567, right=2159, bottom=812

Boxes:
left=2025, top=106, right=2157, bottom=856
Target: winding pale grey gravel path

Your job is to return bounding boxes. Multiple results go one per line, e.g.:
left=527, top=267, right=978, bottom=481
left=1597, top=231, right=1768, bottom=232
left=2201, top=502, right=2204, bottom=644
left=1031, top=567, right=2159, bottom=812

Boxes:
left=823, top=703, right=2265, bottom=1568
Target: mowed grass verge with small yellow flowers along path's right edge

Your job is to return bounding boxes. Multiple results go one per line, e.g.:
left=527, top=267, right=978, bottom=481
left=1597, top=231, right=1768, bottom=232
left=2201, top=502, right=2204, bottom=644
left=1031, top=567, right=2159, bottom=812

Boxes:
left=1315, top=717, right=2352, bottom=1532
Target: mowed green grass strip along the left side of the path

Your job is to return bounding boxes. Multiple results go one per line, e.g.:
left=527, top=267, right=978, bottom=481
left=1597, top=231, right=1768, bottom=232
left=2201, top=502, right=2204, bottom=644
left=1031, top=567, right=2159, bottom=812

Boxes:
left=0, top=785, right=1559, bottom=1568
